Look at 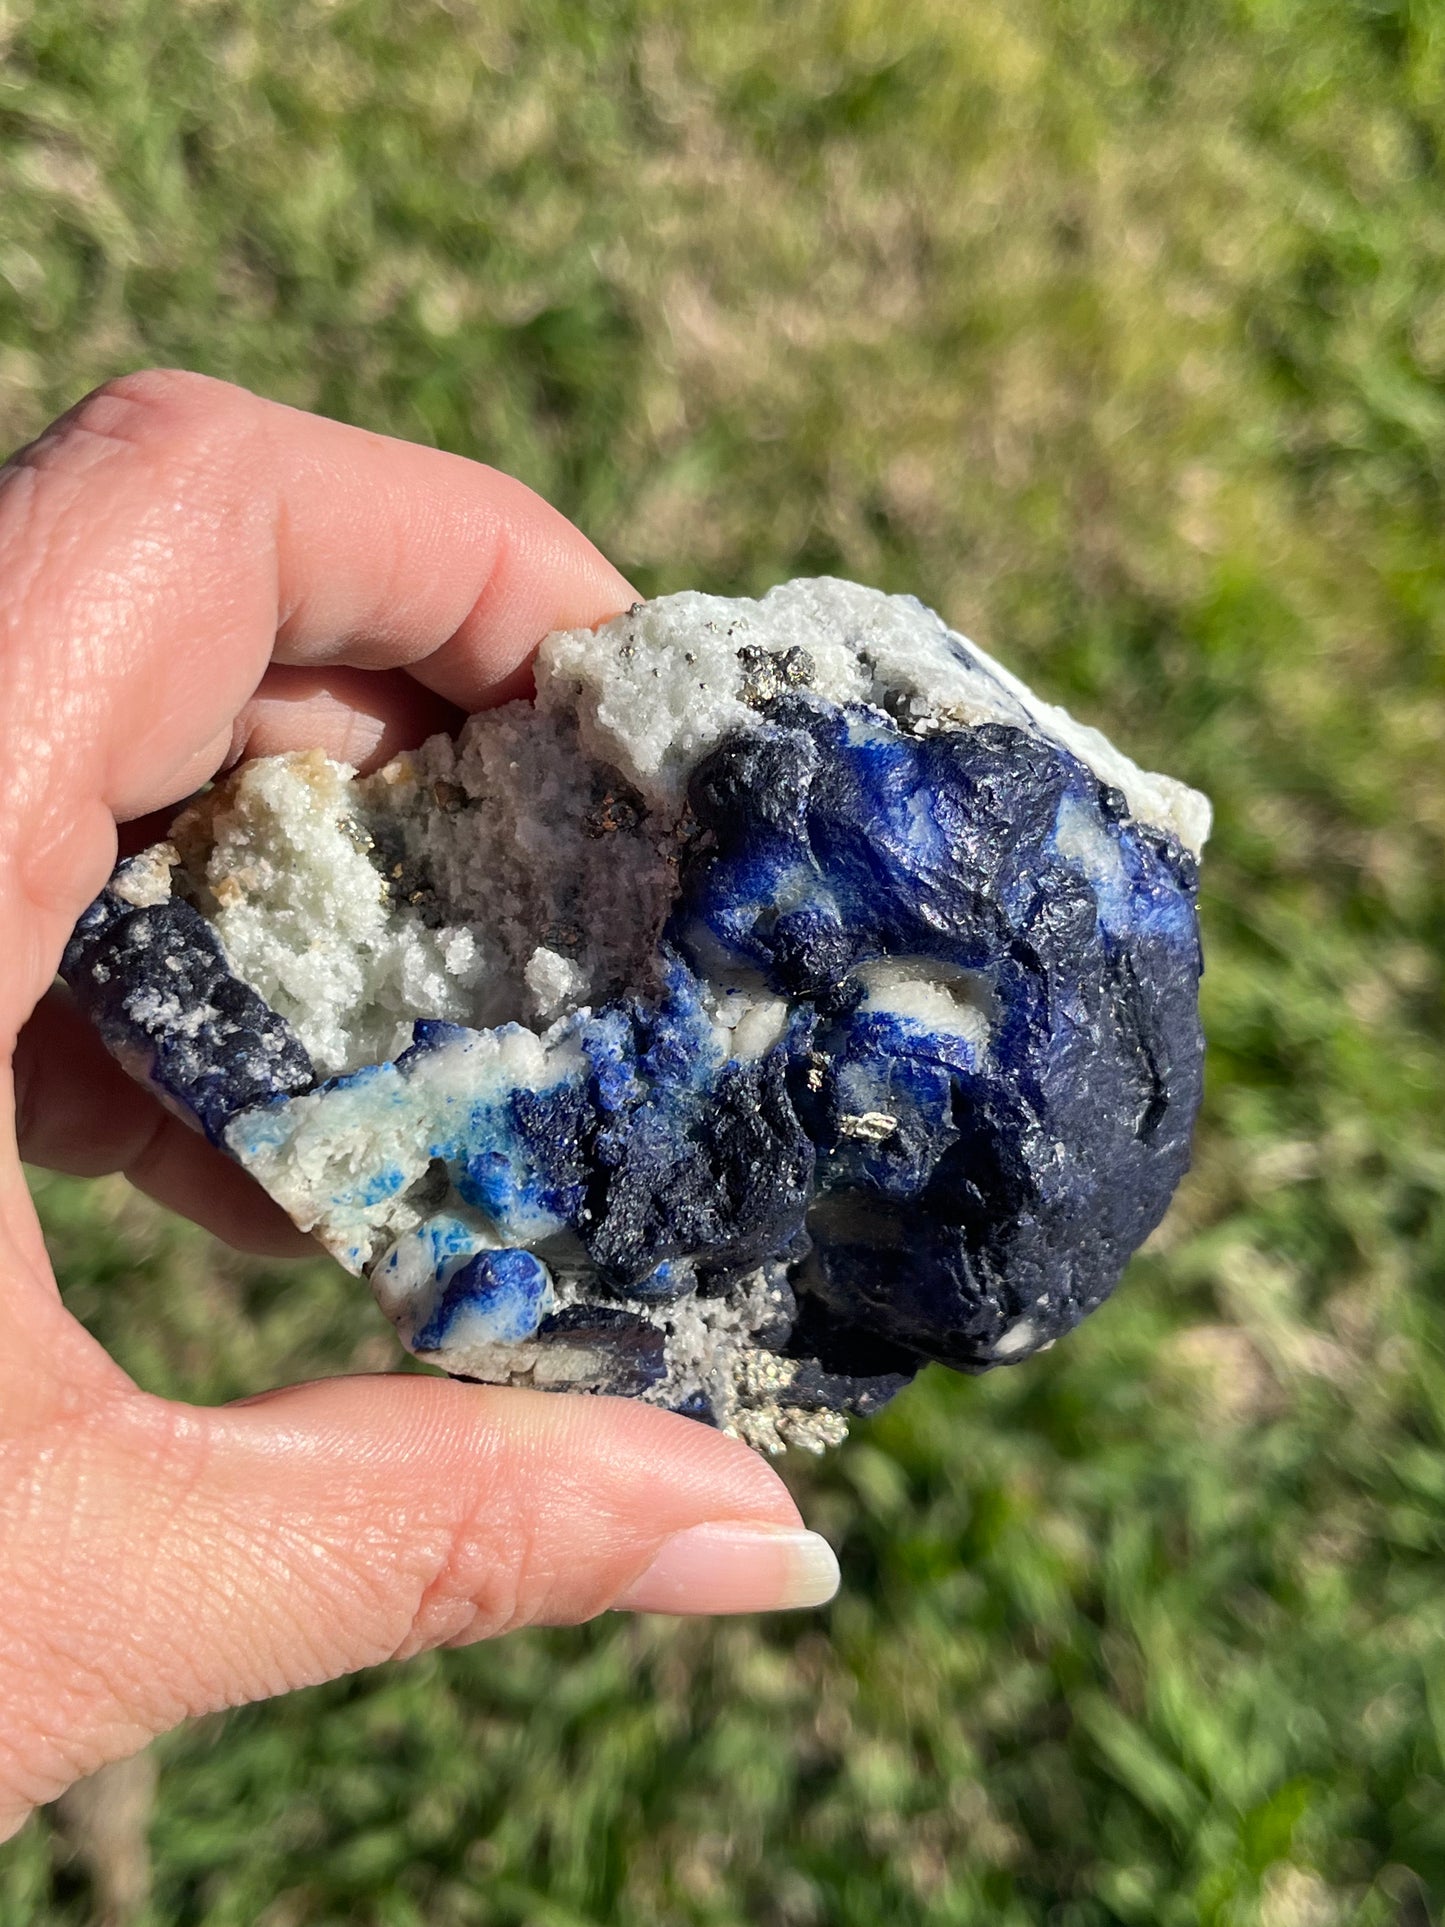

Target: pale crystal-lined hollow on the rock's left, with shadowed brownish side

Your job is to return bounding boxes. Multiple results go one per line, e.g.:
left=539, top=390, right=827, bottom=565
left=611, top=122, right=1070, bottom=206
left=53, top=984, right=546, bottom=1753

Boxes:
left=173, top=703, right=676, bottom=1075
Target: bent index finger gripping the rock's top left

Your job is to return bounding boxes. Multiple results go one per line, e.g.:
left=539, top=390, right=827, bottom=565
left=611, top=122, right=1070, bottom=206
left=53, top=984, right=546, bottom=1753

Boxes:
left=0, top=372, right=632, bottom=1021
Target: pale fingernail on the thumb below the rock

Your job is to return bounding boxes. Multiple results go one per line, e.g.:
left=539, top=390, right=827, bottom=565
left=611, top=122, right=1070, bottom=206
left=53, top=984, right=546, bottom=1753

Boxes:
left=617, top=1520, right=838, bottom=1613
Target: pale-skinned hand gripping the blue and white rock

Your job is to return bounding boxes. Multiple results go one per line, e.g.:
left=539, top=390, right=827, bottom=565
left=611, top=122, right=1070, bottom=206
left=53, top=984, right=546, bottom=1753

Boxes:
left=0, top=372, right=836, bottom=1836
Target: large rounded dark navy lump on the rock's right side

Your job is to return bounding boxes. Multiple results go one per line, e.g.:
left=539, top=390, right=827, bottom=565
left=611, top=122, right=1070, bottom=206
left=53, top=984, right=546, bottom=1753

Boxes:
left=672, top=696, right=1202, bottom=1370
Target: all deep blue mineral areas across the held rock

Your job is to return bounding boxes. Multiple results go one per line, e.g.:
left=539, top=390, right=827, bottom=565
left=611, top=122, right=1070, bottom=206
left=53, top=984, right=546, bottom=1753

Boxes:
left=64, top=585, right=1202, bottom=1449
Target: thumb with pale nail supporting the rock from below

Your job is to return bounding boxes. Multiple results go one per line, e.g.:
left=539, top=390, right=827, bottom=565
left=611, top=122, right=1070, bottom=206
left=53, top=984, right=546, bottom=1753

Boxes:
left=0, top=1348, right=836, bottom=1836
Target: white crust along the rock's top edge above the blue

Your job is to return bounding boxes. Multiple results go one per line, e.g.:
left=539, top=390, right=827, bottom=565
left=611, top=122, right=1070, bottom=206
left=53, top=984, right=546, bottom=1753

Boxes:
left=538, top=576, right=1210, bottom=854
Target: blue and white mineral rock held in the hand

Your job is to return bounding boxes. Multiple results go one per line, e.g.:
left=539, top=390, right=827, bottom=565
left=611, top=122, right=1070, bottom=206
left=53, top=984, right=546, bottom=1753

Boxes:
left=64, top=580, right=1208, bottom=1449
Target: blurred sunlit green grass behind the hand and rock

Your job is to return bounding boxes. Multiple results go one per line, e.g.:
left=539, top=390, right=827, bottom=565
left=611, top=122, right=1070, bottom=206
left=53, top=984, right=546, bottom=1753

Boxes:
left=0, top=0, right=1445, bottom=1927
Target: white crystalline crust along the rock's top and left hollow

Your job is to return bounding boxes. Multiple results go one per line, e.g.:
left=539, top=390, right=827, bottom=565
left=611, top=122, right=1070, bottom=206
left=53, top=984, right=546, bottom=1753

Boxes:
left=157, top=578, right=1210, bottom=1075
